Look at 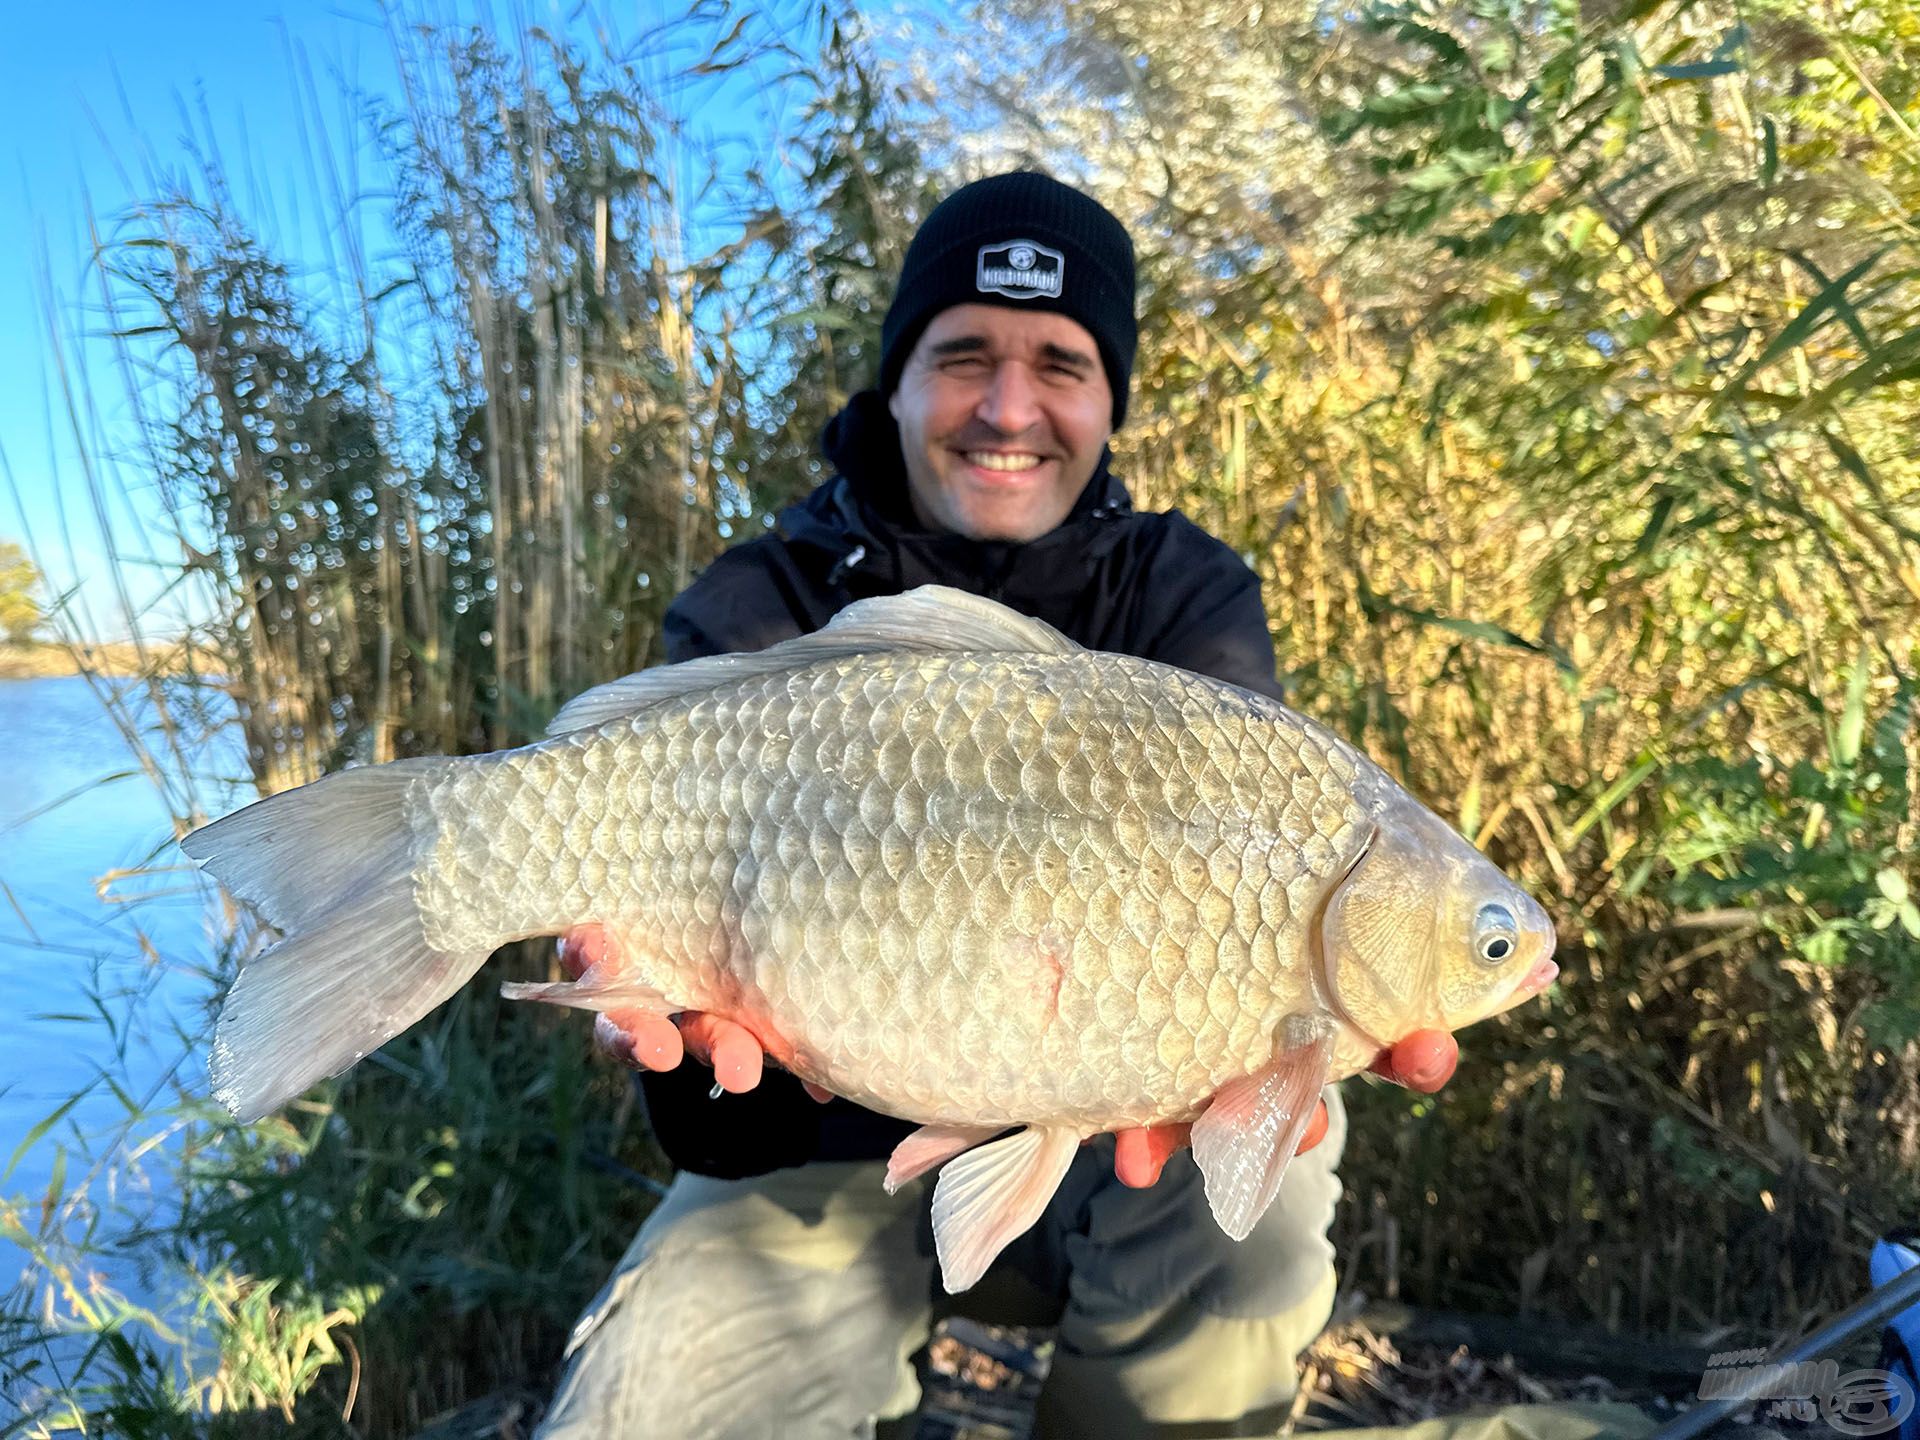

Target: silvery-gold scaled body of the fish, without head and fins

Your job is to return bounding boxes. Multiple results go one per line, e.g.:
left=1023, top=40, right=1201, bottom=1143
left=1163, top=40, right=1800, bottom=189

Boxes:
left=417, top=653, right=1371, bottom=1127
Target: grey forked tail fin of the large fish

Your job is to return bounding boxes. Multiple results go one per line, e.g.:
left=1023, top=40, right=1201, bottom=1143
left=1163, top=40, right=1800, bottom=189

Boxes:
left=180, top=760, right=488, bottom=1121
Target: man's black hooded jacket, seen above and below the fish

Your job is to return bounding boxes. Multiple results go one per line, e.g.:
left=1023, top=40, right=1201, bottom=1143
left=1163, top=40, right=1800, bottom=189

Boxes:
left=641, top=390, right=1279, bottom=1177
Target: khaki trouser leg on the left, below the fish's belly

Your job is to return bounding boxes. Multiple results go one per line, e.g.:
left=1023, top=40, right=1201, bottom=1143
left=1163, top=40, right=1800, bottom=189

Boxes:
left=540, top=1164, right=931, bottom=1440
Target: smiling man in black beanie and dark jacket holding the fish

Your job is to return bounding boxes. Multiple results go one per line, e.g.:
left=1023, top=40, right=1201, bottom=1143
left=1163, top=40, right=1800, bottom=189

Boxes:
left=541, top=173, right=1453, bottom=1440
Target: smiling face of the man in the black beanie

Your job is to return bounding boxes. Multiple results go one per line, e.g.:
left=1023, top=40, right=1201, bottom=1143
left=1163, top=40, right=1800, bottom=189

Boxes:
left=887, top=305, right=1114, bottom=541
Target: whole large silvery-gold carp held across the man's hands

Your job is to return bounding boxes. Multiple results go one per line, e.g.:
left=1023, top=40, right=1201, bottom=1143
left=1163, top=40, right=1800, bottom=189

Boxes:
left=184, top=586, right=1553, bottom=1290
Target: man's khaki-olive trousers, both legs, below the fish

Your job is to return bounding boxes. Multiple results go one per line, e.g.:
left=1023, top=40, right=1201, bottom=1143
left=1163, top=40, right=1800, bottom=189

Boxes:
left=540, top=1087, right=1346, bottom=1440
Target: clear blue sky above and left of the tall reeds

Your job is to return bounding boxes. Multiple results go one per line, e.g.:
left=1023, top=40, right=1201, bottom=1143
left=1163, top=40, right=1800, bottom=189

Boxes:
left=0, top=0, right=844, bottom=637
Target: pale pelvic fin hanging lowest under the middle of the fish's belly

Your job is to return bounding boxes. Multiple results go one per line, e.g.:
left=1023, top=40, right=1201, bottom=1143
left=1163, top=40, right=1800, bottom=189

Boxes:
left=933, top=1127, right=1081, bottom=1294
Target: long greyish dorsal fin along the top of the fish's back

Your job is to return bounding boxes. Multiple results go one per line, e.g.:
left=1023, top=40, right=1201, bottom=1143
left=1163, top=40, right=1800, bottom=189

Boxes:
left=547, top=586, right=1081, bottom=735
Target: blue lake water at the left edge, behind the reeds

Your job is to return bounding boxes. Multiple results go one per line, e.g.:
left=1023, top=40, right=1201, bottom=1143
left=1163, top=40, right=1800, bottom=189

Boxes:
left=0, top=678, right=242, bottom=1328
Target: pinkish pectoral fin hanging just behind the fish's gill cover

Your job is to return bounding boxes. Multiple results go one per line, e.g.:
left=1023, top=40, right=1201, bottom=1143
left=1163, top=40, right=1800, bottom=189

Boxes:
left=1192, top=1018, right=1332, bottom=1240
